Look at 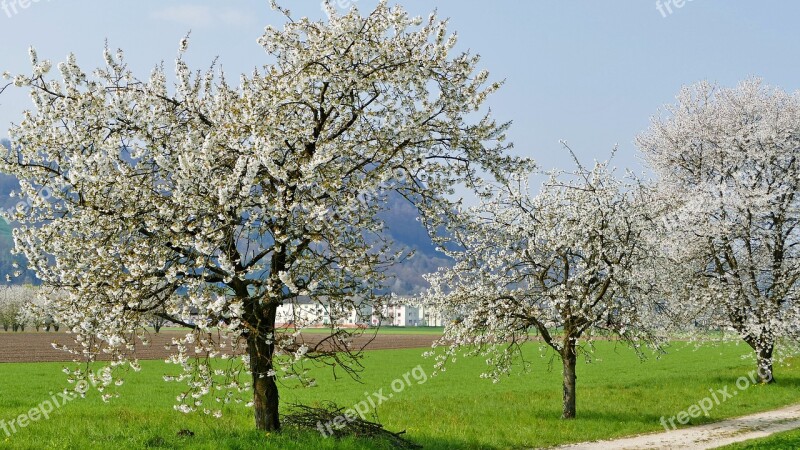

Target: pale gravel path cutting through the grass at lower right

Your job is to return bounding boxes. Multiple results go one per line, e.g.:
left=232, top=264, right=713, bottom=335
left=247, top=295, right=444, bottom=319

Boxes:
left=555, top=404, right=800, bottom=450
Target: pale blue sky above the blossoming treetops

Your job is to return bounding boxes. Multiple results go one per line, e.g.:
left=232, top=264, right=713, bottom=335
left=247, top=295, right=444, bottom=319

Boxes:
left=0, top=0, right=800, bottom=181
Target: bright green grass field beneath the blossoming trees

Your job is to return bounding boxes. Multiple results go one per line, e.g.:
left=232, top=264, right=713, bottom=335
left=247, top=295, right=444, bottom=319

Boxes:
left=0, top=342, right=800, bottom=449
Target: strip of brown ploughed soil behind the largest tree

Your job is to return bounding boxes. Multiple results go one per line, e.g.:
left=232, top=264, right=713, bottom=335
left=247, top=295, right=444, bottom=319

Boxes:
left=0, top=331, right=438, bottom=363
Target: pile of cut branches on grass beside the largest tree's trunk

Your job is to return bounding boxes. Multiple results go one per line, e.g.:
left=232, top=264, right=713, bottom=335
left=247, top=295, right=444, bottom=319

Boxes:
left=283, top=402, right=422, bottom=449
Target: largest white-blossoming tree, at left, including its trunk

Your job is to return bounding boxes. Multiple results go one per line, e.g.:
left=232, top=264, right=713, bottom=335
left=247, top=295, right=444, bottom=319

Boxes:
left=0, top=1, right=526, bottom=430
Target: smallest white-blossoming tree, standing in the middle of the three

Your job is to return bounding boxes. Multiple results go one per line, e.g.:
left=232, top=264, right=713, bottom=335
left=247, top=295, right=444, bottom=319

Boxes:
left=422, top=156, right=660, bottom=419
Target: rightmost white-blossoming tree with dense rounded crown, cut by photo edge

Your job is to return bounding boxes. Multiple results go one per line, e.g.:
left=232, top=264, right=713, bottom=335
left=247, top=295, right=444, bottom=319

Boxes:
left=638, top=80, right=800, bottom=383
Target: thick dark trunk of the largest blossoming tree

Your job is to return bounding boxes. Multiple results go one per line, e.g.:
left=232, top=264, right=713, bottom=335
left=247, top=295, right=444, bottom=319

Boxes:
left=247, top=306, right=281, bottom=431
